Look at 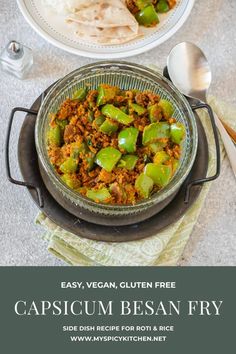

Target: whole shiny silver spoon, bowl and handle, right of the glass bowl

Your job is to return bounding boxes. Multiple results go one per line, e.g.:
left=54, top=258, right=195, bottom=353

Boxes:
left=167, top=42, right=236, bottom=177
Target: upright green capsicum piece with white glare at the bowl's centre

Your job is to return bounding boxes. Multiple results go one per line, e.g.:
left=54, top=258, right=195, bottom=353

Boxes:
left=118, top=127, right=139, bottom=153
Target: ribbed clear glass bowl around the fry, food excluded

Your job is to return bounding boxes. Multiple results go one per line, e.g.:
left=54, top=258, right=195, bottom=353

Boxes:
left=35, top=61, right=198, bottom=224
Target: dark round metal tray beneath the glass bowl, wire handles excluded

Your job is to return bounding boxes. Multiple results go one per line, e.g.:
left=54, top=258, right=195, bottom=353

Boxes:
left=18, top=97, right=208, bottom=242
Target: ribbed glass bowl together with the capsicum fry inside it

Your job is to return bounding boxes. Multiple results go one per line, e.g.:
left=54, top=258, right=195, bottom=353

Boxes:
left=35, top=62, right=197, bottom=225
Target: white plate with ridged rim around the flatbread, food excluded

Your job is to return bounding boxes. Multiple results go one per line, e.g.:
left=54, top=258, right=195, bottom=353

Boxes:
left=17, top=0, right=194, bottom=59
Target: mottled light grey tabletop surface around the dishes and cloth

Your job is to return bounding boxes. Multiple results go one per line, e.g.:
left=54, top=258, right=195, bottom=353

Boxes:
left=0, top=0, right=236, bottom=266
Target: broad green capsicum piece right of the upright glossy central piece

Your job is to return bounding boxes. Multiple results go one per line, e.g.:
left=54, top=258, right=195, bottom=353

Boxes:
left=142, top=122, right=170, bottom=146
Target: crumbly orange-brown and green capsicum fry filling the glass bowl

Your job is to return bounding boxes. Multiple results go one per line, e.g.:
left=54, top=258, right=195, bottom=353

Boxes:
left=47, top=83, right=185, bottom=205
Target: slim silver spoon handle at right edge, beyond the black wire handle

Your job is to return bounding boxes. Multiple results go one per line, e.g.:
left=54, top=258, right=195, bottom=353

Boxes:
left=214, top=113, right=236, bottom=177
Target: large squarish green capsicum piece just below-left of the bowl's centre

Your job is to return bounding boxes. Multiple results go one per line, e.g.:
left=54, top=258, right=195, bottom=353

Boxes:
left=95, top=146, right=121, bottom=172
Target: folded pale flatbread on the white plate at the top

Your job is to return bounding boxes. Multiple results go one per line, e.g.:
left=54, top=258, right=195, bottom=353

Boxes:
left=44, top=0, right=140, bottom=44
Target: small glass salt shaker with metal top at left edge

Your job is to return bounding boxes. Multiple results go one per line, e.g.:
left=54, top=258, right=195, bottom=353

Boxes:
left=0, top=41, right=33, bottom=79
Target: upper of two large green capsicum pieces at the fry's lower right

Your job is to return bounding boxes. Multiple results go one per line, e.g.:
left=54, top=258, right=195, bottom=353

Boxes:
left=144, top=163, right=172, bottom=187
